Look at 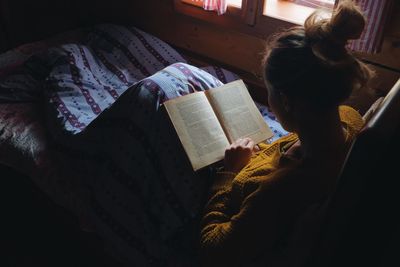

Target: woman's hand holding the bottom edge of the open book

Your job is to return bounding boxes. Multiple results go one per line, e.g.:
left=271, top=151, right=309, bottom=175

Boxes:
left=224, top=138, right=258, bottom=173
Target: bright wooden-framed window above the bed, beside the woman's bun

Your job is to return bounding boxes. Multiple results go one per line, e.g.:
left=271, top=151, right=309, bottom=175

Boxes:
left=174, top=0, right=336, bottom=36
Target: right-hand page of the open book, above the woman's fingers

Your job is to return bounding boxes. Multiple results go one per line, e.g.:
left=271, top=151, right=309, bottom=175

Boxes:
left=206, top=80, right=273, bottom=143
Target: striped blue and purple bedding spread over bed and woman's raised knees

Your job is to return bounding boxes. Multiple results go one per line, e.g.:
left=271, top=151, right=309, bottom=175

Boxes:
left=0, top=24, right=287, bottom=265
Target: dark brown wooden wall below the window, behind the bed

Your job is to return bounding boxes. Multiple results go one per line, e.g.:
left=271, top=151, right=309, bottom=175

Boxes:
left=0, top=0, right=400, bottom=110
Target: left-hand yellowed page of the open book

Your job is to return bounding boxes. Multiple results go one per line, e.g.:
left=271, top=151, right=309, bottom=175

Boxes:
left=164, top=92, right=229, bottom=170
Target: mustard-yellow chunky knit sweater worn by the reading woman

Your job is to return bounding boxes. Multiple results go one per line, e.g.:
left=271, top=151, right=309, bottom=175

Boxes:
left=201, top=106, right=363, bottom=266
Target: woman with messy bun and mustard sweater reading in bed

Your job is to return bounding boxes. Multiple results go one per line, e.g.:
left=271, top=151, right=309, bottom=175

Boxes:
left=201, top=1, right=371, bottom=266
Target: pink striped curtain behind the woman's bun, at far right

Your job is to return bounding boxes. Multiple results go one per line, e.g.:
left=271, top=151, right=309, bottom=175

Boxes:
left=349, top=0, right=394, bottom=53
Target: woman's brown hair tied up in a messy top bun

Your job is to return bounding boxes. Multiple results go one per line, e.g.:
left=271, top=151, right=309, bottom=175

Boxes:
left=264, top=1, right=372, bottom=110
